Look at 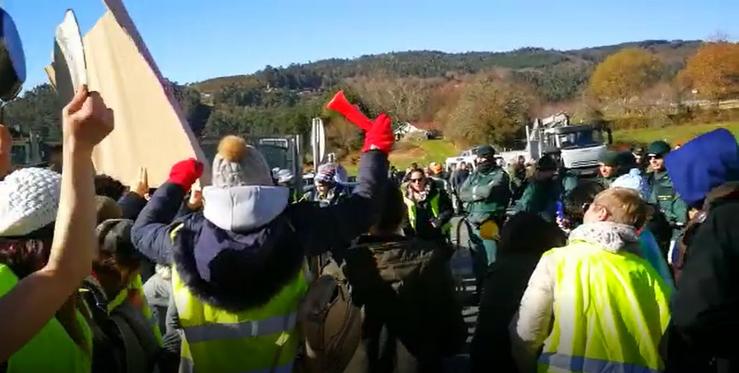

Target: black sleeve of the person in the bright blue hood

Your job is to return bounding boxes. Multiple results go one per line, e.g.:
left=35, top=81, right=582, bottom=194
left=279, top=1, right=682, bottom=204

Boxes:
left=672, top=202, right=739, bottom=357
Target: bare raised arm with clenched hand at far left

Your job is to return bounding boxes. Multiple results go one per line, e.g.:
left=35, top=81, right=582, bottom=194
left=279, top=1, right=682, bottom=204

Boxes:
left=0, top=87, right=113, bottom=361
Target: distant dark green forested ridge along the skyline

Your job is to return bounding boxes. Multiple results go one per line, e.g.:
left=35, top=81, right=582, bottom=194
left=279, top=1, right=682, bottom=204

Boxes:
left=193, top=40, right=701, bottom=96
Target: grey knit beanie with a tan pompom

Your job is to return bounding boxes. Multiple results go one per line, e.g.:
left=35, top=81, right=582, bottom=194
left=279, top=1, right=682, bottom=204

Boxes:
left=213, top=136, right=273, bottom=188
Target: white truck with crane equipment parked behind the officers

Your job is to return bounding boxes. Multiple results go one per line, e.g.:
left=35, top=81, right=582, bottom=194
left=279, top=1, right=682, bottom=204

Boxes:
left=500, top=113, right=613, bottom=175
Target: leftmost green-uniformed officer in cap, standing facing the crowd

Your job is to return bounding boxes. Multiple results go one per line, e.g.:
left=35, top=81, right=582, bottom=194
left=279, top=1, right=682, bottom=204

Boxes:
left=459, top=145, right=511, bottom=284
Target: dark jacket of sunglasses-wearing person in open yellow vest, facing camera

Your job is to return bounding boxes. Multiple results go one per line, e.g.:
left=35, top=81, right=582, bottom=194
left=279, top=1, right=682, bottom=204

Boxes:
left=405, top=182, right=454, bottom=240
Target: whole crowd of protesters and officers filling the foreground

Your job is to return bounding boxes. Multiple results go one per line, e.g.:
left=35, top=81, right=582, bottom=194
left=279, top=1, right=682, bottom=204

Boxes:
left=0, top=87, right=739, bottom=372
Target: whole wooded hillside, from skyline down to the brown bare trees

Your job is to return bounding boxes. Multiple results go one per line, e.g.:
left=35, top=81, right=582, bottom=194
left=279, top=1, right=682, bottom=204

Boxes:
left=5, top=40, right=701, bottom=152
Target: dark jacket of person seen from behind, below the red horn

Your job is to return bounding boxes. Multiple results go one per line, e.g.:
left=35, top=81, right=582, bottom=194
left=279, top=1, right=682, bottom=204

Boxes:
left=344, top=236, right=466, bottom=373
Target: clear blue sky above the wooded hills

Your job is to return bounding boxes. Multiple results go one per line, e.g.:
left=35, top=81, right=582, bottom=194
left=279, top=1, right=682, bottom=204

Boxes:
left=0, top=0, right=739, bottom=88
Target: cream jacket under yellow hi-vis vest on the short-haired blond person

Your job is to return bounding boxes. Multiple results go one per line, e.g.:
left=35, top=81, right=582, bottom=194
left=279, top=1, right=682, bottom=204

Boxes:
left=511, top=222, right=670, bottom=372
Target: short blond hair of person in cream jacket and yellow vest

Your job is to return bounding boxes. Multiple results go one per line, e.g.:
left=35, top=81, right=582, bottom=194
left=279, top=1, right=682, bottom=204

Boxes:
left=593, top=187, right=653, bottom=228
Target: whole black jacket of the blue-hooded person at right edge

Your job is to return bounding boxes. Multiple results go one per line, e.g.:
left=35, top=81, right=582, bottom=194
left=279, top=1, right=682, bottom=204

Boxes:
left=664, top=185, right=739, bottom=372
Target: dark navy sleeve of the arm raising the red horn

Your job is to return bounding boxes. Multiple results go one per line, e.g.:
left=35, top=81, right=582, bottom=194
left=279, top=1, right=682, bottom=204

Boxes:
left=288, top=150, right=388, bottom=256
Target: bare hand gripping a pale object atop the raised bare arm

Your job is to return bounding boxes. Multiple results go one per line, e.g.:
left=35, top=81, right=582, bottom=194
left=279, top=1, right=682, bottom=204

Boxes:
left=62, top=85, right=113, bottom=152
